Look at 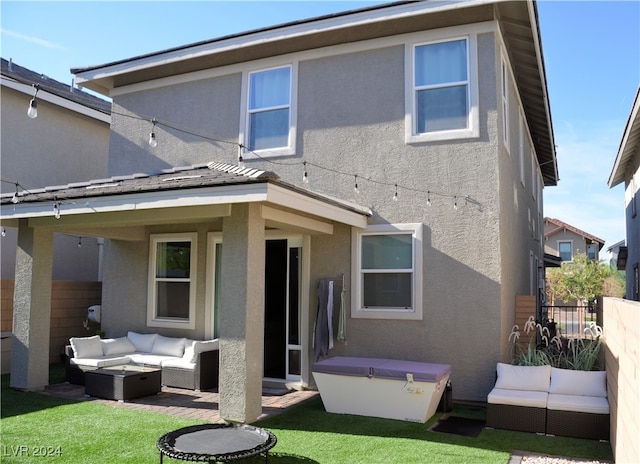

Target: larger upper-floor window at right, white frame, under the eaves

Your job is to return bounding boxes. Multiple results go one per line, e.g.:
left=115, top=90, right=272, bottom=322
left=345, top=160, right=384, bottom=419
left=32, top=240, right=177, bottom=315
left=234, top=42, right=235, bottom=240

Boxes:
left=407, top=36, right=479, bottom=143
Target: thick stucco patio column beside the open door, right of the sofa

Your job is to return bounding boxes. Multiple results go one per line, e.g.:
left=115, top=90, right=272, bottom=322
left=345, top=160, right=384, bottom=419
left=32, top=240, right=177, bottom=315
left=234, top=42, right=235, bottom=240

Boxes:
left=219, top=203, right=265, bottom=423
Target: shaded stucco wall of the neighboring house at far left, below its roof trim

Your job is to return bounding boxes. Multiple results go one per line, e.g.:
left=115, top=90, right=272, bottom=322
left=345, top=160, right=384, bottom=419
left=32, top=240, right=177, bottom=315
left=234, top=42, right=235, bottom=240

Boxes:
left=0, top=86, right=109, bottom=280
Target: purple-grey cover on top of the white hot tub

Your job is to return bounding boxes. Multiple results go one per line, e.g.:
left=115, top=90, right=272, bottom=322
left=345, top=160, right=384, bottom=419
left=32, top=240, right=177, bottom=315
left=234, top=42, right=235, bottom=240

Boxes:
left=312, top=356, right=451, bottom=382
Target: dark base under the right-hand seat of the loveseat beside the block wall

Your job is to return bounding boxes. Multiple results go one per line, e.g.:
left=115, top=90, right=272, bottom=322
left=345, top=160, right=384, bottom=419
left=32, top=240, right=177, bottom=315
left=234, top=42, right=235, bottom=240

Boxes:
left=547, top=409, right=610, bottom=440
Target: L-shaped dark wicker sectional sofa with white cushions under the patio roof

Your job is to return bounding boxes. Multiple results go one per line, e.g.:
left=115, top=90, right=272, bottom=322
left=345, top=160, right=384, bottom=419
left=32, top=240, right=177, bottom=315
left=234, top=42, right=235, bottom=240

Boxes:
left=65, top=332, right=219, bottom=390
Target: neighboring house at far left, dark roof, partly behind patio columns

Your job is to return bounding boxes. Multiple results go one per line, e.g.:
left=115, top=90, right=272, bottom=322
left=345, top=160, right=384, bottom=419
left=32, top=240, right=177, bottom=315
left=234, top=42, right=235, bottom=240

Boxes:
left=0, top=58, right=111, bottom=366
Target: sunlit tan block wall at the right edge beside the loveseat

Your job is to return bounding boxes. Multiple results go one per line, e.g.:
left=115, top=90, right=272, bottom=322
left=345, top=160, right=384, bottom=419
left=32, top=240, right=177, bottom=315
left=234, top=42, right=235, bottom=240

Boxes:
left=603, top=298, right=640, bottom=463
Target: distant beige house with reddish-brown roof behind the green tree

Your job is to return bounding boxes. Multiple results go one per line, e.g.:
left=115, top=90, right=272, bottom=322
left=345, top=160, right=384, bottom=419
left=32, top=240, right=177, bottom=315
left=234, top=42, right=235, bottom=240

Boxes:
left=544, top=218, right=604, bottom=261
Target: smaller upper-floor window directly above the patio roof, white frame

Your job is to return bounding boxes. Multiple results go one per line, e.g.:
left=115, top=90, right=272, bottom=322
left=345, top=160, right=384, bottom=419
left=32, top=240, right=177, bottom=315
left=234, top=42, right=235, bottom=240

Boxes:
left=243, top=65, right=295, bottom=157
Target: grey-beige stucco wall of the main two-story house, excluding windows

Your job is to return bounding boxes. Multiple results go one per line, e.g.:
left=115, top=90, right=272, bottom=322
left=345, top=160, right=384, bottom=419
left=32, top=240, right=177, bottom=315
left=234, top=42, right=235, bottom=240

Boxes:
left=103, top=27, right=533, bottom=401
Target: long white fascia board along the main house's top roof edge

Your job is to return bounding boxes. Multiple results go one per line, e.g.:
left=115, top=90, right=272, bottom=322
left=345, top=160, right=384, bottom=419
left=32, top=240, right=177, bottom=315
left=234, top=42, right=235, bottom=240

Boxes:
left=76, top=0, right=494, bottom=89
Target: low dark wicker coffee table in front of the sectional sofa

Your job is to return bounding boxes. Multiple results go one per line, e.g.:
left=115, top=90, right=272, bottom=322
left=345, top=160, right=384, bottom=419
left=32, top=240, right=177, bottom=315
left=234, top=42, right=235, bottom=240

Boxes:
left=84, top=365, right=162, bottom=401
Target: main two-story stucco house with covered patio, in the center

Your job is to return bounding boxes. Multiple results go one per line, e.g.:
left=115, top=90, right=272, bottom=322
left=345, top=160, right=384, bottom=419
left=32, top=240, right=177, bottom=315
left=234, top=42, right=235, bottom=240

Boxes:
left=1, top=0, right=558, bottom=422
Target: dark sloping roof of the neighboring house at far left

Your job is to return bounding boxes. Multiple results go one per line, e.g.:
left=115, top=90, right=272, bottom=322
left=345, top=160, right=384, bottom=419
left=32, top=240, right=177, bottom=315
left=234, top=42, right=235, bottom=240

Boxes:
left=0, top=58, right=111, bottom=114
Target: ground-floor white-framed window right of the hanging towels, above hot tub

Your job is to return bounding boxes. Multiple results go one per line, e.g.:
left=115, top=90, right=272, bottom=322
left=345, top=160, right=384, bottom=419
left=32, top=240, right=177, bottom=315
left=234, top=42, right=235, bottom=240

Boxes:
left=351, top=224, right=422, bottom=320
